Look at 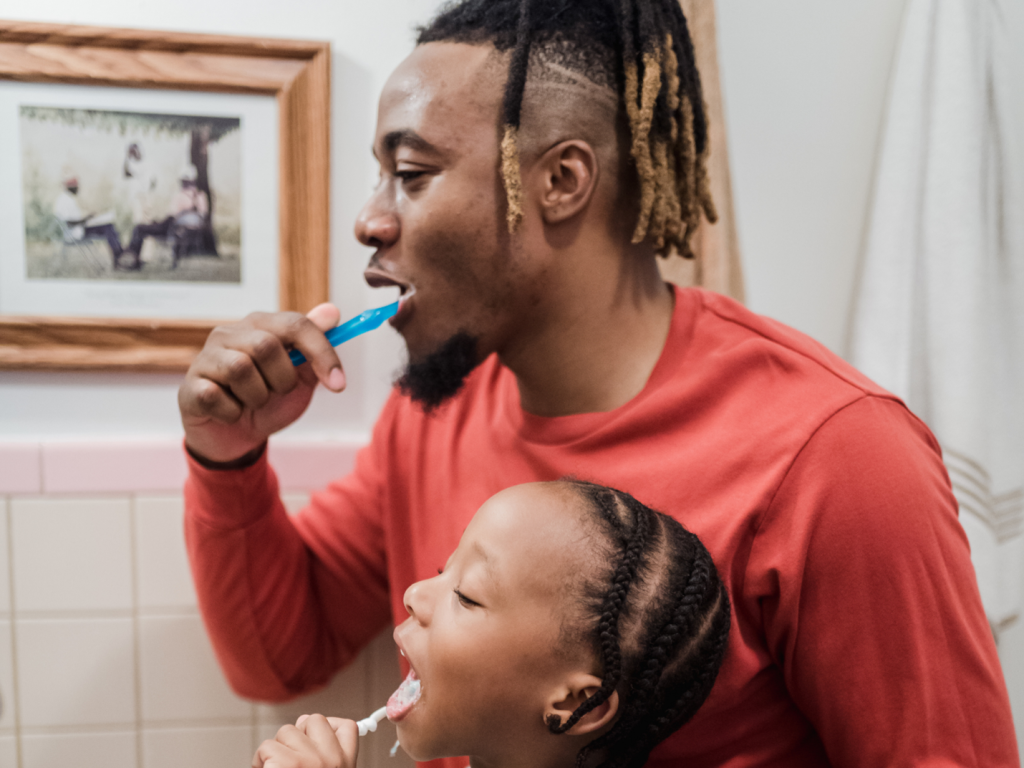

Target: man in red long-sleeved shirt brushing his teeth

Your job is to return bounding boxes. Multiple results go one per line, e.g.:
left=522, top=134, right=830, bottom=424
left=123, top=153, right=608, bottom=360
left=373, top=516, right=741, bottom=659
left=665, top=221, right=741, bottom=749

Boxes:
left=179, top=0, right=1018, bottom=768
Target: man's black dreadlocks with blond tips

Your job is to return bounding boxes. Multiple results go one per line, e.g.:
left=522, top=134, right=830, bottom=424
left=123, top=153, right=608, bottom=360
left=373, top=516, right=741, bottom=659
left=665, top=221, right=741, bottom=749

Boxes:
left=417, top=0, right=718, bottom=257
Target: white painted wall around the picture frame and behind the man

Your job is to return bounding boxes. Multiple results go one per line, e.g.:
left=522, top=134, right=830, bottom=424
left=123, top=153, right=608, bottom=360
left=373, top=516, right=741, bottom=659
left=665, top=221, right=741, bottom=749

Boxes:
left=0, top=0, right=1024, bottom=761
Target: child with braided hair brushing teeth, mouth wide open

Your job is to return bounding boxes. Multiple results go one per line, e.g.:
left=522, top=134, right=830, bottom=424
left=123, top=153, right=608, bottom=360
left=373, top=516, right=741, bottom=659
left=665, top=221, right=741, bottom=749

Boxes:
left=253, top=480, right=729, bottom=768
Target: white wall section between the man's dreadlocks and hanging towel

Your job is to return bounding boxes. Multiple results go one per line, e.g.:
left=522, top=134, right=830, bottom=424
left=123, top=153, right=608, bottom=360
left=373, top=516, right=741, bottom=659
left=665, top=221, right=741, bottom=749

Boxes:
left=718, top=0, right=905, bottom=352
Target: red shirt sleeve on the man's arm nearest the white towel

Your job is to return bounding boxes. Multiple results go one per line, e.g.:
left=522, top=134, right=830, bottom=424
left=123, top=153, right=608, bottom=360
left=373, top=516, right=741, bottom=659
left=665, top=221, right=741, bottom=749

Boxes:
left=744, top=397, right=1020, bottom=768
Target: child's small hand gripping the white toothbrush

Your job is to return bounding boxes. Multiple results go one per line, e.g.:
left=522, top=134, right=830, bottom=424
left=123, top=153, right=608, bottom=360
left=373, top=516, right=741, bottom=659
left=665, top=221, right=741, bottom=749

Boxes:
left=252, top=715, right=359, bottom=768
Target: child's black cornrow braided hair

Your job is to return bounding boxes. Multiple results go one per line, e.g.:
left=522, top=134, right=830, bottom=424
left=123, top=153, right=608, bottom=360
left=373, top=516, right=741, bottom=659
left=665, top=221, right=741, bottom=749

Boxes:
left=561, top=479, right=730, bottom=768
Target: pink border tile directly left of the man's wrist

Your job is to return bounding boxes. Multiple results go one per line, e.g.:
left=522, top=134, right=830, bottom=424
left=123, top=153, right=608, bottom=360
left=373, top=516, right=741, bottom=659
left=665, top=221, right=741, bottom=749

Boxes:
left=42, top=438, right=185, bottom=494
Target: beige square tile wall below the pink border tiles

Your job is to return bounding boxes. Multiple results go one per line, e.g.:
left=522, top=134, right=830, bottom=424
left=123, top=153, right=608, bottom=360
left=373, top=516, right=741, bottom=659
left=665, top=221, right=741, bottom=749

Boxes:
left=0, top=494, right=412, bottom=768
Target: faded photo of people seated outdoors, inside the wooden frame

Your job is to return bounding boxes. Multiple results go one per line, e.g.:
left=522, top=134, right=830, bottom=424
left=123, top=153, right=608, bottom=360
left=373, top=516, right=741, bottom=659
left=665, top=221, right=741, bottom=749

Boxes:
left=19, top=105, right=242, bottom=283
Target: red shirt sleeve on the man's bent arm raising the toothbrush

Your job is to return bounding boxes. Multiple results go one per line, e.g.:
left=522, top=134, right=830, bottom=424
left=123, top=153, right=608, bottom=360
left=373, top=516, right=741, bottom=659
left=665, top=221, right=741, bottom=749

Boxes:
left=185, top=409, right=390, bottom=700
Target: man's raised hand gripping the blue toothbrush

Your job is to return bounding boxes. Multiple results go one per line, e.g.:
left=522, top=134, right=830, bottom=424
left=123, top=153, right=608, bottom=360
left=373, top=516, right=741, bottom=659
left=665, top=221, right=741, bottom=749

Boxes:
left=178, top=304, right=345, bottom=462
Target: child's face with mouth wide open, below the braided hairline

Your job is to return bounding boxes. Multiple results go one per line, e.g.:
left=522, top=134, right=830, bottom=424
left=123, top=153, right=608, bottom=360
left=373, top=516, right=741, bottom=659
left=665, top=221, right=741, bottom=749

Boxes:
left=395, top=483, right=597, bottom=764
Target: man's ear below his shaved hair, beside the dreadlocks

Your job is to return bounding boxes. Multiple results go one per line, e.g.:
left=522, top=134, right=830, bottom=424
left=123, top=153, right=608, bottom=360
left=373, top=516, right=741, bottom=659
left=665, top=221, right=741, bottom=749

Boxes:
left=535, top=139, right=599, bottom=224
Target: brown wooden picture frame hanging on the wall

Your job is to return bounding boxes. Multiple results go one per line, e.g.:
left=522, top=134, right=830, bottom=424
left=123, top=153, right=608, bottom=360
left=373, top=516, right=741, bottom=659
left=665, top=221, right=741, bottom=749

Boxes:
left=0, top=20, right=331, bottom=371
